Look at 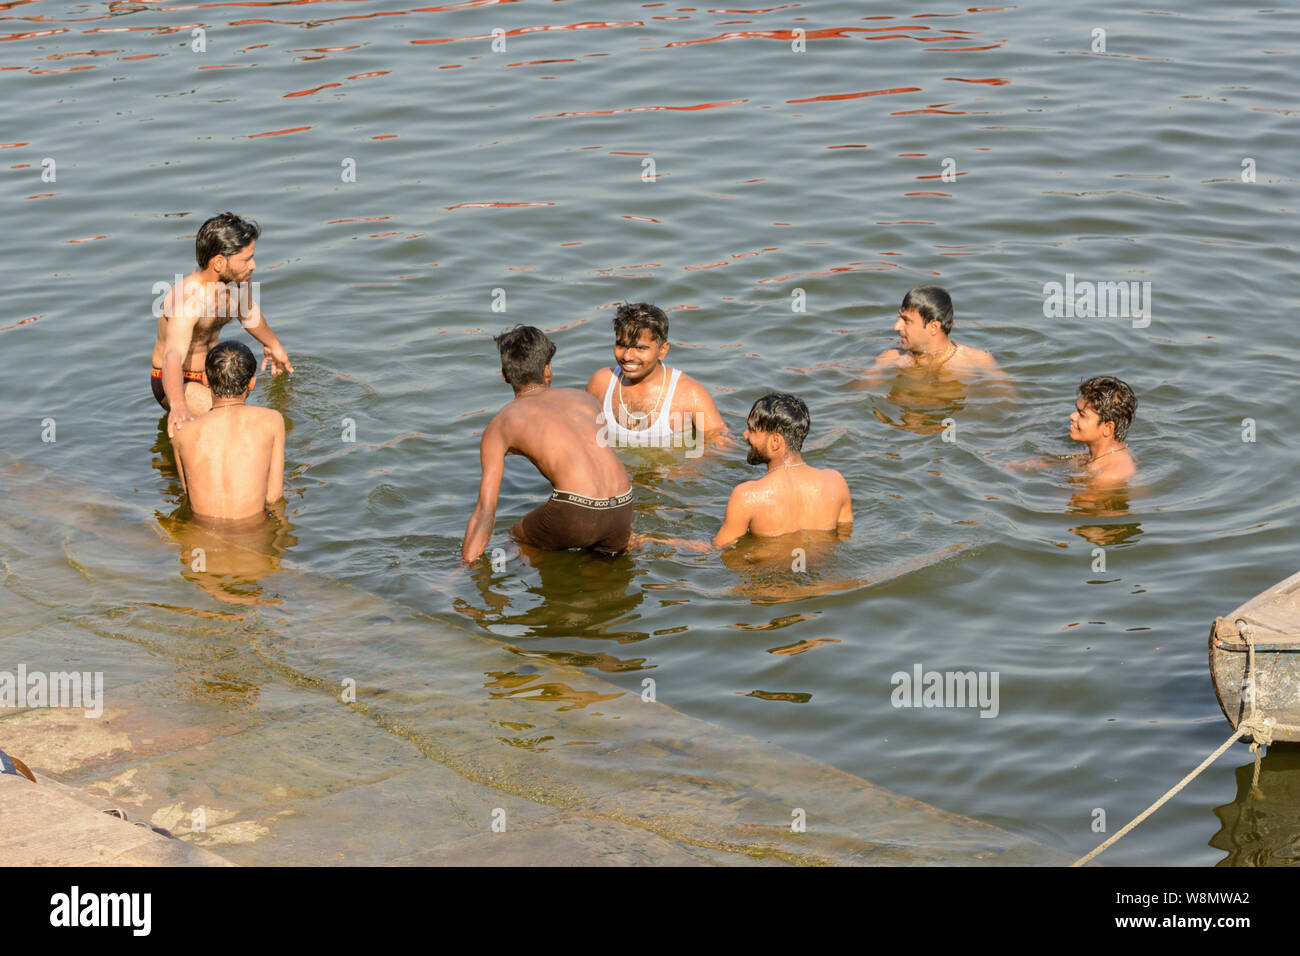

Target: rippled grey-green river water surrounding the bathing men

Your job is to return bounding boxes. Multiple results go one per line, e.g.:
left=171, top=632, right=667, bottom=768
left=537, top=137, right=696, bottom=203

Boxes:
left=0, top=0, right=1300, bottom=865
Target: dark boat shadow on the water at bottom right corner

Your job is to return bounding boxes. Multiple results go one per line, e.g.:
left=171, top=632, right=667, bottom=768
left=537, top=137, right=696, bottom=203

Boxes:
left=1209, top=744, right=1300, bottom=866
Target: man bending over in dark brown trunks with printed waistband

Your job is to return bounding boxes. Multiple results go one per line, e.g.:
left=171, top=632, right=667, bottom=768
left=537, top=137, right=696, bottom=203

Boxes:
left=460, top=325, right=633, bottom=562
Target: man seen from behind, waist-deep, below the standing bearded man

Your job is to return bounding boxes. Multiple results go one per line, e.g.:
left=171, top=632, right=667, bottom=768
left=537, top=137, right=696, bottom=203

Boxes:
left=172, top=342, right=285, bottom=520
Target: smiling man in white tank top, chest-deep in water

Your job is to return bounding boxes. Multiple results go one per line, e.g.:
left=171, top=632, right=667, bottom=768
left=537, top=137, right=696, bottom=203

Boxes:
left=586, top=302, right=728, bottom=447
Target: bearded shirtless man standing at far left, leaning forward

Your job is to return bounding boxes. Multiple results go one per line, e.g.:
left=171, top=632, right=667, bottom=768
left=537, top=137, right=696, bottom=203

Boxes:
left=150, top=212, right=294, bottom=437
